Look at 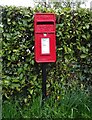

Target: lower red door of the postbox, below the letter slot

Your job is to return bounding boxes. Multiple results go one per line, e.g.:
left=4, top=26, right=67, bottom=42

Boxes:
left=35, top=33, right=56, bottom=62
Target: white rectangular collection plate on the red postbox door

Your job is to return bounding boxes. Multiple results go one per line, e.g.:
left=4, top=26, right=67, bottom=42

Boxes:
left=41, top=38, right=50, bottom=54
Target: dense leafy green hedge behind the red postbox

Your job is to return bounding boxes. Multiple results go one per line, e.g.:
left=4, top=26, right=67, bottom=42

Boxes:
left=2, top=7, right=92, bottom=104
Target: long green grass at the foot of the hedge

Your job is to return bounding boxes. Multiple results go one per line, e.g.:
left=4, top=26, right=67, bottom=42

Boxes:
left=2, top=90, right=92, bottom=119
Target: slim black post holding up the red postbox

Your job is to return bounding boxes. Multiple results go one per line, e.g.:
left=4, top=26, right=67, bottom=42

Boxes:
left=42, top=63, right=47, bottom=105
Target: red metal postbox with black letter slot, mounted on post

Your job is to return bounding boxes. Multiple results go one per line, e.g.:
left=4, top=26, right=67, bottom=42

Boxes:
left=34, top=13, right=56, bottom=63
